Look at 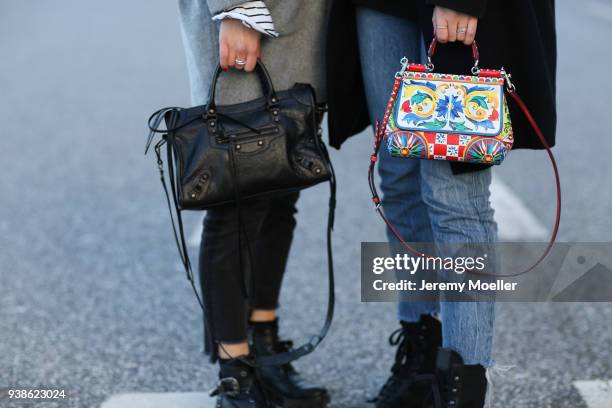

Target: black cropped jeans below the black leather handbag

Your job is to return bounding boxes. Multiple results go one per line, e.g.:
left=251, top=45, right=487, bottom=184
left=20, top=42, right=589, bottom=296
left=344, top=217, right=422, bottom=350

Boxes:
left=199, top=193, right=299, bottom=360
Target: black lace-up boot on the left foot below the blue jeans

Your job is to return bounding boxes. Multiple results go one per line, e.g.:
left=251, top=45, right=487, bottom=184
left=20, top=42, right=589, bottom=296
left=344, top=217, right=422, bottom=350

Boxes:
left=370, top=315, right=442, bottom=408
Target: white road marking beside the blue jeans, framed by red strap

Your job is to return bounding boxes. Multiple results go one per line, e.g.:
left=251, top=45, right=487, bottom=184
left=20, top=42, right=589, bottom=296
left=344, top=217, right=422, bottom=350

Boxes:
left=491, top=177, right=548, bottom=241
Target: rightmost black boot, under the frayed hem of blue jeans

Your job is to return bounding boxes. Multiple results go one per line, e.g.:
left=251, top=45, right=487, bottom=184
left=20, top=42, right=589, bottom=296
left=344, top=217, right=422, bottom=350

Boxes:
left=429, top=348, right=487, bottom=408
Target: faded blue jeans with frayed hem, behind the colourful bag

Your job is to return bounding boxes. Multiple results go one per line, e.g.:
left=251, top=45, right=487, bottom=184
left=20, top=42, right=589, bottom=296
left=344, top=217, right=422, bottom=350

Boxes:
left=357, top=7, right=497, bottom=367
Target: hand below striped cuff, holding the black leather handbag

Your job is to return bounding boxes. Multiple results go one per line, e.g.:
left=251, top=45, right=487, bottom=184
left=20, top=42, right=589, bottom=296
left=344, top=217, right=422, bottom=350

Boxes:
left=219, top=19, right=261, bottom=72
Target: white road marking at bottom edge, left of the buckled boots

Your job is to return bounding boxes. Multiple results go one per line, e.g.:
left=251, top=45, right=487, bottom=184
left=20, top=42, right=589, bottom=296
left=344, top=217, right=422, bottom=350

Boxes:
left=100, top=392, right=215, bottom=408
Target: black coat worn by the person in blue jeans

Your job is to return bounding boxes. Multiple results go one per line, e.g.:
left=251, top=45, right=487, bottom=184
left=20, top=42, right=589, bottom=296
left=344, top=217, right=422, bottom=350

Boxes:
left=327, top=0, right=557, bottom=173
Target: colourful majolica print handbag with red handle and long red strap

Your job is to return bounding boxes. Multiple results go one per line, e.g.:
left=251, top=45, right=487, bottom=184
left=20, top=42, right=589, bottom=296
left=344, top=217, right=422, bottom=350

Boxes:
left=368, top=38, right=561, bottom=276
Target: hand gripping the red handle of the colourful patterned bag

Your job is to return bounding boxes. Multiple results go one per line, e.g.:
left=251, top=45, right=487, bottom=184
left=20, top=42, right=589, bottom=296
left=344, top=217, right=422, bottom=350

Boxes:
left=432, top=6, right=478, bottom=45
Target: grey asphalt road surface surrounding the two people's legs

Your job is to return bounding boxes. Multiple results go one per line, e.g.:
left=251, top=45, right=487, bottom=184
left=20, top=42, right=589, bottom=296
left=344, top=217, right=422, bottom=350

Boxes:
left=0, top=0, right=612, bottom=408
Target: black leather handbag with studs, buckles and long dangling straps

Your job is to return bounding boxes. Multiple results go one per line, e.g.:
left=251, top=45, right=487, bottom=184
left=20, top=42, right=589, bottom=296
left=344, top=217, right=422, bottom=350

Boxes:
left=145, top=62, right=336, bottom=365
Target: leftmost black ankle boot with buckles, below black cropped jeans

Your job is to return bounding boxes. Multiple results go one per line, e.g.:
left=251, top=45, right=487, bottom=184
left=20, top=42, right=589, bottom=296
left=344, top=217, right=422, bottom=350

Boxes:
left=210, top=359, right=269, bottom=408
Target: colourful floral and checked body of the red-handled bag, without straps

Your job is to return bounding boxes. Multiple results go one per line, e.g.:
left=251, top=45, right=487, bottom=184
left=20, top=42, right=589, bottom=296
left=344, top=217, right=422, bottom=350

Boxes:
left=386, top=72, right=513, bottom=164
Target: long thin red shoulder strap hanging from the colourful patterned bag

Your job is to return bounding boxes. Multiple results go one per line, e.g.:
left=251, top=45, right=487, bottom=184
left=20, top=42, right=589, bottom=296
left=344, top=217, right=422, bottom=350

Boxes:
left=368, top=81, right=561, bottom=277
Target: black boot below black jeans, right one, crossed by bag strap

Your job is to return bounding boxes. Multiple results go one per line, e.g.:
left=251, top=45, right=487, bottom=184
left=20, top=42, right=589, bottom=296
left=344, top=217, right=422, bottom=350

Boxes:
left=249, top=320, right=330, bottom=408
